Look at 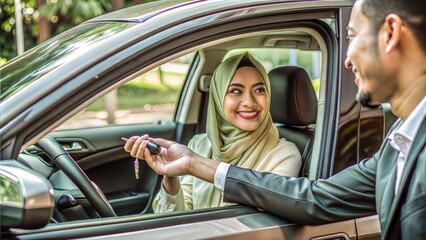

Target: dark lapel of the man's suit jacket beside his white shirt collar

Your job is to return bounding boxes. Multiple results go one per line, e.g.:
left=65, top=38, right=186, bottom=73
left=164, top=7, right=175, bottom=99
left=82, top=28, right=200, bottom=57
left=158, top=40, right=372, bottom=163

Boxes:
left=382, top=119, right=426, bottom=237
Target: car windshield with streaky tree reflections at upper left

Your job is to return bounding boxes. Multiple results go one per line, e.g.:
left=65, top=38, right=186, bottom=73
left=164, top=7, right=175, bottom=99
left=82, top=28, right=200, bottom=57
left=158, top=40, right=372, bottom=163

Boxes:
left=0, top=23, right=134, bottom=101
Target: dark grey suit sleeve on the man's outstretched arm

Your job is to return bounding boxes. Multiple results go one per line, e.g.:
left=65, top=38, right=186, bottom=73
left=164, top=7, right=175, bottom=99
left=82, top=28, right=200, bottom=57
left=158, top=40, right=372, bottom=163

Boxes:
left=224, top=157, right=377, bottom=224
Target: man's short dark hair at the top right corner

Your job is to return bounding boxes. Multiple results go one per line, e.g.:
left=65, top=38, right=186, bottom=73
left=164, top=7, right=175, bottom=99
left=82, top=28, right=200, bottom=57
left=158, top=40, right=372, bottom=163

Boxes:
left=360, top=0, right=426, bottom=54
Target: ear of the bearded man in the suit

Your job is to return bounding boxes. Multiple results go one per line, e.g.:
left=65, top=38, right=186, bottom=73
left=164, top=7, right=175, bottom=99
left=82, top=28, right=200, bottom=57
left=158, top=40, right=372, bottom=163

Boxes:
left=383, top=14, right=402, bottom=53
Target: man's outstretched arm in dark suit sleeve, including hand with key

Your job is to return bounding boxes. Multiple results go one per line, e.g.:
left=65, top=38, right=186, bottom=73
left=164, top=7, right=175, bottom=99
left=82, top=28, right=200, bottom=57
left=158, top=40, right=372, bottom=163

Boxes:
left=125, top=139, right=378, bottom=224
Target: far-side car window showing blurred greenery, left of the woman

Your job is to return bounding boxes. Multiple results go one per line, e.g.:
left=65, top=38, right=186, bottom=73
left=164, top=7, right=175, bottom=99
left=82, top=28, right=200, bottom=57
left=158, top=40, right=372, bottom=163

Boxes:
left=57, top=53, right=195, bottom=129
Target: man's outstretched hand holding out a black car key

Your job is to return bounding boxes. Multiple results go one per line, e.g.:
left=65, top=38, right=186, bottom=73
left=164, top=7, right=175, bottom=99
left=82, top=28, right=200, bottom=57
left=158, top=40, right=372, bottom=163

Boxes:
left=124, top=134, right=194, bottom=177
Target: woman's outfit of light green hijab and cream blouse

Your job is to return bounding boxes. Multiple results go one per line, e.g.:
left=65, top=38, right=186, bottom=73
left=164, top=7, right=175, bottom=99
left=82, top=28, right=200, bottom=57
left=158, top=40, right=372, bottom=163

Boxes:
left=153, top=53, right=300, bottom=212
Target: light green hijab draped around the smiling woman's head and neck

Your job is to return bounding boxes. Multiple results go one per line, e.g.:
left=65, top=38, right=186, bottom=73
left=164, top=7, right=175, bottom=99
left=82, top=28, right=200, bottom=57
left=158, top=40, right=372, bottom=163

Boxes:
left=190, top=52, right=279, bottom=171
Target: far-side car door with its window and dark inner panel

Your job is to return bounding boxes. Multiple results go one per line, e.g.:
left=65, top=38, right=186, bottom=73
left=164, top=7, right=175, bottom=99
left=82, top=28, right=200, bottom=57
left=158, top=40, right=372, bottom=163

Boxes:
left=42, top=53, right=196, bottom=216
